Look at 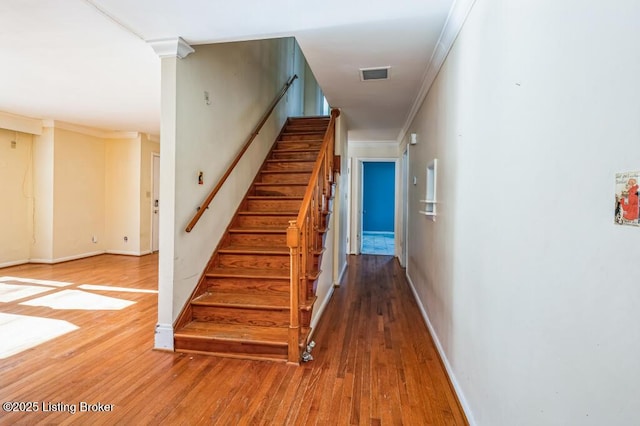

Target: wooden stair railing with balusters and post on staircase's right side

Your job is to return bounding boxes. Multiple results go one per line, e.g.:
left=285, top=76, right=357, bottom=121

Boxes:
left=287, top=109, right=340, bottom=364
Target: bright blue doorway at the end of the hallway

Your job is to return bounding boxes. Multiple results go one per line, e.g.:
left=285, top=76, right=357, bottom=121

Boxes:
left=360, top=161, right=396, bottom=256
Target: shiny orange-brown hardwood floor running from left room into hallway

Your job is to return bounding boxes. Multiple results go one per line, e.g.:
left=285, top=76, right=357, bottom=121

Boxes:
left=0, top=255, right=467, bottom=425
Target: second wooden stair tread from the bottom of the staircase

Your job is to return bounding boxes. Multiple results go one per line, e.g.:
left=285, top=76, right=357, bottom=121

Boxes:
left=191, top=291, right=289, bottom=310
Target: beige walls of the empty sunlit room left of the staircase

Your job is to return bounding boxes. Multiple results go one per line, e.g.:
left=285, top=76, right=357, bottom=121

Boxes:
left=0, top=116, right=159, bottom=266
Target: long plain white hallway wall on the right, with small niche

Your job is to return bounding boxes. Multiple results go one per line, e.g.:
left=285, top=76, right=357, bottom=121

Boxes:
left=405, top=0, right=640, bottom=426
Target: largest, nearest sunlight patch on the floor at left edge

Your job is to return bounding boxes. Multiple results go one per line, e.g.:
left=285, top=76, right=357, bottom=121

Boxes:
left=0, top=312, right=78, bottom=359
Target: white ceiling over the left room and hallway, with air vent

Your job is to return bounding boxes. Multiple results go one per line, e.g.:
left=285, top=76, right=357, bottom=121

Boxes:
left=0, top=0, right=453, bottom=141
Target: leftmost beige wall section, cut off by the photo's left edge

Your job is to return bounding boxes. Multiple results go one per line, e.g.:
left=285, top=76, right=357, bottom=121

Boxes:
left=0, top=129, right=33, bottom=267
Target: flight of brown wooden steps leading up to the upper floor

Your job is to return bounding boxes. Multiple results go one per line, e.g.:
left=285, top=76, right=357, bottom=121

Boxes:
left=174, top=117, right=336, bottom=362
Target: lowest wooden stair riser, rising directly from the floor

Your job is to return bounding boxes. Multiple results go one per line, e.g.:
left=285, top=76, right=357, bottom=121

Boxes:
left=174, top=335, right=287, bottom=361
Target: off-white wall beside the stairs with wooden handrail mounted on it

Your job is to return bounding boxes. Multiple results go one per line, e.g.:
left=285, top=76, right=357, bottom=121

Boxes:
left=156, top=39, right=304, bottom=332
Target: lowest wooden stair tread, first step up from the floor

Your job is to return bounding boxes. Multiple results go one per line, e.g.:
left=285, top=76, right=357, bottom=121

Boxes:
left=174, top=321, right=289, bottom=346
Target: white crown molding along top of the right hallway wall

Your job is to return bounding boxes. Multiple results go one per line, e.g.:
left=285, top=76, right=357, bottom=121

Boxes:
left=397, top=0, right=476, bottom=145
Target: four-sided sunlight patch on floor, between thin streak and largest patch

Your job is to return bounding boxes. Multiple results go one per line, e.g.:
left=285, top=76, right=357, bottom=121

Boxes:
left=20, top=290, right=135, bottom=311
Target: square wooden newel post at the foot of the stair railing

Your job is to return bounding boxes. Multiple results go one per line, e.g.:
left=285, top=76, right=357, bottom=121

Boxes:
left=287, top=220, right=300, bottom=364
